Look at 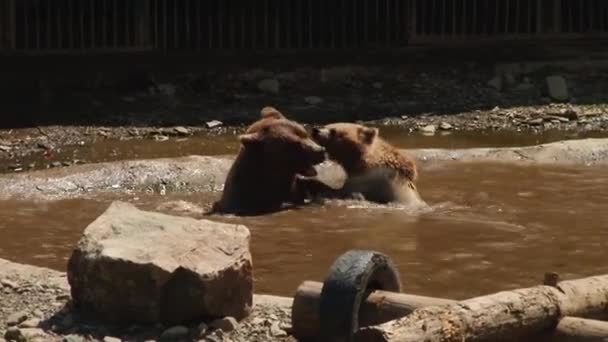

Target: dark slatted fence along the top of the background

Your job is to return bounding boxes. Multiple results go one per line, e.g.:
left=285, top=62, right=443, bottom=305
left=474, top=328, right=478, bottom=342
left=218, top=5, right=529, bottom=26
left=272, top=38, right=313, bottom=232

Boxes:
left=0, top=0, right=608, bottom=54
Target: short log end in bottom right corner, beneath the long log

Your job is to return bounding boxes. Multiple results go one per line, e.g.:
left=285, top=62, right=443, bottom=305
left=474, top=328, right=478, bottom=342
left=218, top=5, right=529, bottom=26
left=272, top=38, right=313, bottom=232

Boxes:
left=551, top=317, right=608, bottom=342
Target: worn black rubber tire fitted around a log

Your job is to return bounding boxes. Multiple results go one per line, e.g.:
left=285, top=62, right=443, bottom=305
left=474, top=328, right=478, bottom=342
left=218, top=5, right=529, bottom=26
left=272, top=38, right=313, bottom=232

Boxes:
left=319, top=250, right=401, bottom=341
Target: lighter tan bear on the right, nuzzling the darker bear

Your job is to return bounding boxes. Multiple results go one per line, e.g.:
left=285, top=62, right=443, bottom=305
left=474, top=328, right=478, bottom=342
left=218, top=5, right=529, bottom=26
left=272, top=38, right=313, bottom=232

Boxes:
left=306, top=123, right=426, bottom=206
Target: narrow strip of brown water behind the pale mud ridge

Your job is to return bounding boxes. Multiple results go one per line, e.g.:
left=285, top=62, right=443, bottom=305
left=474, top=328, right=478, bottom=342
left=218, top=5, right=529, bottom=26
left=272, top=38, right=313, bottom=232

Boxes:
left=5, top=126, right=608, bottom=172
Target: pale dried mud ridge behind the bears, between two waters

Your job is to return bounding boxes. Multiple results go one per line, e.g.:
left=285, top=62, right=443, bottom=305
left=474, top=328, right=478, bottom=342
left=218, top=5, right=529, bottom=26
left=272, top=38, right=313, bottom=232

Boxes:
left=0, top=139, right=608, bottom=199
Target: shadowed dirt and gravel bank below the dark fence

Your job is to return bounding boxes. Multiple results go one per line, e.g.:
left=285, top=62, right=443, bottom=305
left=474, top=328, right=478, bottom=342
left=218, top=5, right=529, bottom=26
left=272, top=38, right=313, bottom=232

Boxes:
left=0, top=57, right=608, bottom=172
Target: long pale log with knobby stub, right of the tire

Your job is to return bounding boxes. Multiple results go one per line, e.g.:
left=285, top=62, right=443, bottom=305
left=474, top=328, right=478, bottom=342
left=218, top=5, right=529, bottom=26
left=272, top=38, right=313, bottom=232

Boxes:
left=356, top=275, right=608, bottom=342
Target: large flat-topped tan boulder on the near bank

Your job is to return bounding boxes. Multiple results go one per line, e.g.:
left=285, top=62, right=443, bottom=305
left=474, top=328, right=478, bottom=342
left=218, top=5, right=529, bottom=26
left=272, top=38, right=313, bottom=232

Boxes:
left=68, top=202, right=253, bottom=324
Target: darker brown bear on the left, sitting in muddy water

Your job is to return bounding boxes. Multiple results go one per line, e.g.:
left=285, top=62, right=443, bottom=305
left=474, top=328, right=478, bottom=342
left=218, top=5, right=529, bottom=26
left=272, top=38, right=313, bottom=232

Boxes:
left=209, top=107, right=325, bottom=215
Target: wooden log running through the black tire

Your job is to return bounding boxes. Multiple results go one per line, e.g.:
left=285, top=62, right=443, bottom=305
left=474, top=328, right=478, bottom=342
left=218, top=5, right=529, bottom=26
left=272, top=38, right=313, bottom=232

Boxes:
left=292, top=281, right=456, bottom=340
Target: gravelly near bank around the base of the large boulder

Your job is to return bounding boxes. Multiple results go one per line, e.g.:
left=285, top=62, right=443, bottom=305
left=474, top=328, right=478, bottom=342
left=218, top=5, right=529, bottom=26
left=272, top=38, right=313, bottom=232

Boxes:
left=0, top=259, right=293, bottom=342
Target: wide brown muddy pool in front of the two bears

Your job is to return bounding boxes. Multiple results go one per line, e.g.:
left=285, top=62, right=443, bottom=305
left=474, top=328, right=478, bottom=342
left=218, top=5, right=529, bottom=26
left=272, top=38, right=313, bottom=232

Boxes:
left=0, top=163, right=608, bottom=298
